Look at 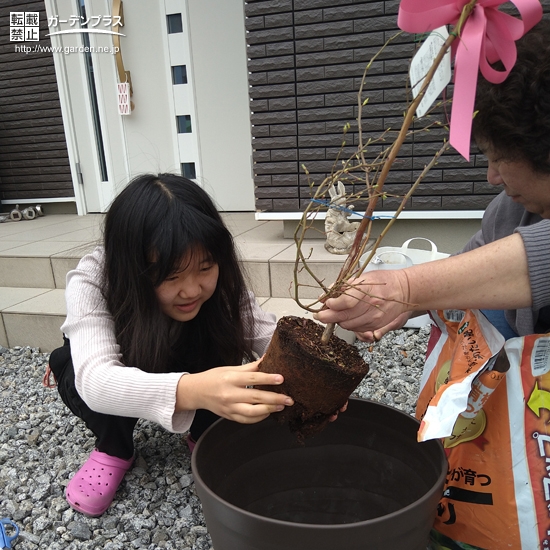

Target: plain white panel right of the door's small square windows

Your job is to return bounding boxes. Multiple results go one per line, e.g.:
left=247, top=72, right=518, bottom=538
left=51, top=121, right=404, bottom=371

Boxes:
left=188, top=0, right=254, bottom=211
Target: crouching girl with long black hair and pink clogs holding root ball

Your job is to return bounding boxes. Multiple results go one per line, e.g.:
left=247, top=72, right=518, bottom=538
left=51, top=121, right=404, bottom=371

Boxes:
left=50, top=174, right=293, bottom=516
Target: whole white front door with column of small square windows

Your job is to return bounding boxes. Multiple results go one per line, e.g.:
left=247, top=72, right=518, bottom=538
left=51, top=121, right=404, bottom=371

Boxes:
left=46, top=0, right=254, bottom=213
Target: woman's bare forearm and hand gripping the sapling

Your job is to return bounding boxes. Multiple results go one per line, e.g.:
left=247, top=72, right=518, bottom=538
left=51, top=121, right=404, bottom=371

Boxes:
left=317, top=234, right=532, bottom=332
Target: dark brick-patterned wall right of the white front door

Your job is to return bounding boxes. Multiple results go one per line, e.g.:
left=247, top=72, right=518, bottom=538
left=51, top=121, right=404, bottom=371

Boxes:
left=245, top=0, right=550, bottom=212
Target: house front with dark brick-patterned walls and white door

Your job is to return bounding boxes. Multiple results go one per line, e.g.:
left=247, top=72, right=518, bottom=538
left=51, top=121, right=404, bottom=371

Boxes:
left=0, top=0, right=550, bottom=219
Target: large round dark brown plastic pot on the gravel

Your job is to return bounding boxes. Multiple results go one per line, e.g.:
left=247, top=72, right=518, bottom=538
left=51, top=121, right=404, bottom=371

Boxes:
left=191, top=399, right=447, bottom=550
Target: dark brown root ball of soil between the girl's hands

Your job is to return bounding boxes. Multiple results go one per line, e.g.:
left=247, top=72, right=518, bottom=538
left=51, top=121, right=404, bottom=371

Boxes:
left=260, top=316, right=369, bottom=440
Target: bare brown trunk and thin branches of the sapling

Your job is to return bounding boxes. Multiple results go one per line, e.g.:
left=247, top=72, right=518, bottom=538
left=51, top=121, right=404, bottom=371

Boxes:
left=294, top=0, right=477, bottom=343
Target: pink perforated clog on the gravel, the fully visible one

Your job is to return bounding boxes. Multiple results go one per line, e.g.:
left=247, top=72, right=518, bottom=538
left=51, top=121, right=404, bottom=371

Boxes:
left=65, top=450, right=134, bottom=517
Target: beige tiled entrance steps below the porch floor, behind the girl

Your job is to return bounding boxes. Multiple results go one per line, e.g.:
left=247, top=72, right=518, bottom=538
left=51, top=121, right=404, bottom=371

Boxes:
left=0, top=242, right=352, bottom=352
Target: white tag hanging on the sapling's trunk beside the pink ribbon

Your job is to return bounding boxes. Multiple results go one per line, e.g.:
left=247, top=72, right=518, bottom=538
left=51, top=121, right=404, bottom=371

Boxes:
left=409, top=26, right=451, bottom=118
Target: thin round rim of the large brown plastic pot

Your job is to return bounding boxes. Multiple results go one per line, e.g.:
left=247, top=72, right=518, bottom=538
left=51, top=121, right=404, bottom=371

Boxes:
left=191, top=397, right=447, bottom=530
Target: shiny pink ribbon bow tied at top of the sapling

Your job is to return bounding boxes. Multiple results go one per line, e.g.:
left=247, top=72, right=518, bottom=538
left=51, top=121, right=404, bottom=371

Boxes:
left=397, top=0, right=542, bottom=160
